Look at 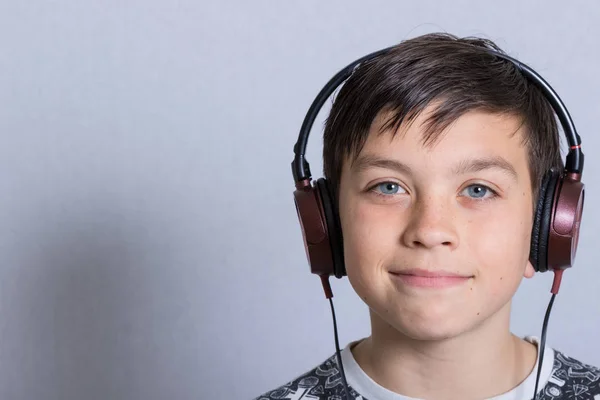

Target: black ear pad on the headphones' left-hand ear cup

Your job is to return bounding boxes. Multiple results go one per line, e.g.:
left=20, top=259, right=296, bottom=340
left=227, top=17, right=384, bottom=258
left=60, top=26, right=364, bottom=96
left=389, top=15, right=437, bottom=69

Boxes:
left=316, top=178, right=346, bottom=278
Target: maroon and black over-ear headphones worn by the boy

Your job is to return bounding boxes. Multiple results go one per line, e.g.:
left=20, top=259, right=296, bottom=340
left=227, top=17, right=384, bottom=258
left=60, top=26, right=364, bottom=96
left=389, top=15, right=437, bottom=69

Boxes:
left=292, top=46, right=585, bottom=284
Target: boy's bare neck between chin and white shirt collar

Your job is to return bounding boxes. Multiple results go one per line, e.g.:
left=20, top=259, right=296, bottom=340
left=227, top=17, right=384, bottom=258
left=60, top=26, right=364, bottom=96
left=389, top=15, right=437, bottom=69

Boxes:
left=352, top=307, right=537, bottom=399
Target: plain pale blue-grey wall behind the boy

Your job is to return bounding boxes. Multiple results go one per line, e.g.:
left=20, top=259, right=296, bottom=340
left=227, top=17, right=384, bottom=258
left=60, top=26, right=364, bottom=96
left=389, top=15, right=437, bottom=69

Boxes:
left=0, top=0, right=600, bottom=400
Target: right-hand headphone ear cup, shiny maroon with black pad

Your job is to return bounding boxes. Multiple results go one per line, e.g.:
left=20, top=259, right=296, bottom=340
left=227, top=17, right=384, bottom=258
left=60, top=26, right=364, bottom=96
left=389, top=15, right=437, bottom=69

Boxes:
left=529, top=170, right=584, bottom=272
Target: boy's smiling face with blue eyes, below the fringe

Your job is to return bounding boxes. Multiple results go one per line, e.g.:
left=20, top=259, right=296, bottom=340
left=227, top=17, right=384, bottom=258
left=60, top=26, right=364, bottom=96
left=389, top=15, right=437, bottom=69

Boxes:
left=339, top=110, right=534, bottom=340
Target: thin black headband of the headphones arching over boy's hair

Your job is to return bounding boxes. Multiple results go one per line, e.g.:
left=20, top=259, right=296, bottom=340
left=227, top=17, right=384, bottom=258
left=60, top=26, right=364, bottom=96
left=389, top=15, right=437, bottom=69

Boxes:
left=292, top=46, right=584, bottom=183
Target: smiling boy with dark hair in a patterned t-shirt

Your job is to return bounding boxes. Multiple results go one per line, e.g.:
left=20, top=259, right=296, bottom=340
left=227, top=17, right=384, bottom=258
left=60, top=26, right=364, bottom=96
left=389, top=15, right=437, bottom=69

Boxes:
left=252, top=34, right=600, bottom=400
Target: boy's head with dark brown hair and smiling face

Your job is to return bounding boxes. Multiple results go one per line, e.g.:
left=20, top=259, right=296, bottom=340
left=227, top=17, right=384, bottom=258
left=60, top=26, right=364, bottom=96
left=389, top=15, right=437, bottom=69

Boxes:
left=323, top=34, right=562, bottom=340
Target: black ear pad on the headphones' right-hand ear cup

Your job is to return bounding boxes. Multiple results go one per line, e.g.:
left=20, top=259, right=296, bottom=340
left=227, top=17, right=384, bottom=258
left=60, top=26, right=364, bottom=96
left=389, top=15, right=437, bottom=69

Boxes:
left=529, top=169, right=560, bottom=272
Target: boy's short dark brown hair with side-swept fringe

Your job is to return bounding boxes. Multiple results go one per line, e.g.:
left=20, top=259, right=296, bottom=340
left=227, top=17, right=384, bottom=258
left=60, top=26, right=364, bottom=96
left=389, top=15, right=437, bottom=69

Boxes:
left=323, top=33, right=563, bottom=205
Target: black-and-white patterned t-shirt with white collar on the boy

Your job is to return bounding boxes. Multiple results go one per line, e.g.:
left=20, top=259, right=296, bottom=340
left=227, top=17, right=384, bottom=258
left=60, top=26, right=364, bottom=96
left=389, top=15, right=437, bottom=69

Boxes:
left=255, top=338, right=600, bottom=400
